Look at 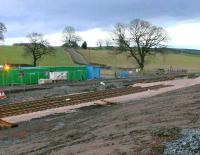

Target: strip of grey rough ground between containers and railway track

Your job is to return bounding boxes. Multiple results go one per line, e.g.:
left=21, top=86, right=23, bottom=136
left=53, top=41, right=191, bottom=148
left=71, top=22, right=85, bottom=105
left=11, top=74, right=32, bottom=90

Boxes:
left=0, top=74, right=191, bottom=105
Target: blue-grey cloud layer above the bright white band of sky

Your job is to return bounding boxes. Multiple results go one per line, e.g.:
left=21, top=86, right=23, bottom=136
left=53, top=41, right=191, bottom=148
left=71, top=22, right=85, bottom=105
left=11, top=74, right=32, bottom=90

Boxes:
left=0, top=0, right=200, bottom=36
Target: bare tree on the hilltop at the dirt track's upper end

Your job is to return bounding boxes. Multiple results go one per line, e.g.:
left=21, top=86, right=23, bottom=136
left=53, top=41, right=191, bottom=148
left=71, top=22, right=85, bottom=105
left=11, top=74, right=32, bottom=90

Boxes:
left=63, top=26, right=81, bottom=47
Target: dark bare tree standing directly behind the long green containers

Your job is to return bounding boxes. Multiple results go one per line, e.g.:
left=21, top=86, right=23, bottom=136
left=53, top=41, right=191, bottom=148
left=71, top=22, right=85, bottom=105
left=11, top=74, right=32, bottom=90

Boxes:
left=25, top=33, right=55, bottom=66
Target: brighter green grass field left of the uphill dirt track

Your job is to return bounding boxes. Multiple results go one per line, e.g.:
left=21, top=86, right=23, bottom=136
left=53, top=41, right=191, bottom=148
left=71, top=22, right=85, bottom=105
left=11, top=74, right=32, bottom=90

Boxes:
left=0, top=46, right=73, bottom=66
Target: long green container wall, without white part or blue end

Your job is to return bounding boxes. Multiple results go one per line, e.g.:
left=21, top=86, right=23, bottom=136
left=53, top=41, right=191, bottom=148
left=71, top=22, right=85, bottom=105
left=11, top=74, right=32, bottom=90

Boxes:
left=0, top=66, right=87, bottom=86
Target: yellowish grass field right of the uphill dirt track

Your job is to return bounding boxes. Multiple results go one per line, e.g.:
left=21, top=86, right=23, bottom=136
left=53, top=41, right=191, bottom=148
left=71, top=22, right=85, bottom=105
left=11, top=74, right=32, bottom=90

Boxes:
left=79, top=49, right=200, bottom=72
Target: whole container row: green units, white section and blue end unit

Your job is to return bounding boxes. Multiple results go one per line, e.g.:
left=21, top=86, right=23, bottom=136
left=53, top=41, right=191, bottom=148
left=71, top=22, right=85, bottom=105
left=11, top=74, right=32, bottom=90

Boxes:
left=0, top=66, right=100, bottom=86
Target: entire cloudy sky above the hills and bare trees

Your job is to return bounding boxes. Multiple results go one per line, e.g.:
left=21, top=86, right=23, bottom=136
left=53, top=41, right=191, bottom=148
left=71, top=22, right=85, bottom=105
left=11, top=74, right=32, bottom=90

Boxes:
left=0, top=0, right=200, bottom=49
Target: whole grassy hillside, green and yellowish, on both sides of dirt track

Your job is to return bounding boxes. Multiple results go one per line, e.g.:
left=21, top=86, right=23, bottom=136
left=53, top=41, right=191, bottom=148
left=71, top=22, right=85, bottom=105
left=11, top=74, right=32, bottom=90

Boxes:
left=0, top=46, right=200, bottom=72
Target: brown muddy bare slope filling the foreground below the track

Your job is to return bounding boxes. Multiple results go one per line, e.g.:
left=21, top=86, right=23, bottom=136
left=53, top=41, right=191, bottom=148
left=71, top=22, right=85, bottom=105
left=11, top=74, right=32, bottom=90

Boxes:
left=0, top=85, right=200, bottom=155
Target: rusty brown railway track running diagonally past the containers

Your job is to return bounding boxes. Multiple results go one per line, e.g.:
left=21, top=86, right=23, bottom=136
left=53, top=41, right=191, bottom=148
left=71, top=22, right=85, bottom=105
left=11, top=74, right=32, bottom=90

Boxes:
left=0, top=85, right=170, bottom=118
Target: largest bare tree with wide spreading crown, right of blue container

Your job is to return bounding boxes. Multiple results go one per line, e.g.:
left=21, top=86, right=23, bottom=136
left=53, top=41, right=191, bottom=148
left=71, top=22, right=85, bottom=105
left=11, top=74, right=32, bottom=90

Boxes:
left=114, top=19, right=168, bottom=70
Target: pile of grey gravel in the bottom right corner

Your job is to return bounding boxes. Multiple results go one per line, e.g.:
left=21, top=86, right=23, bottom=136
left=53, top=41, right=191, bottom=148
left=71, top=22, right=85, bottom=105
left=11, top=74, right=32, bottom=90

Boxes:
left=163, top=129, right=200, bottom=155
